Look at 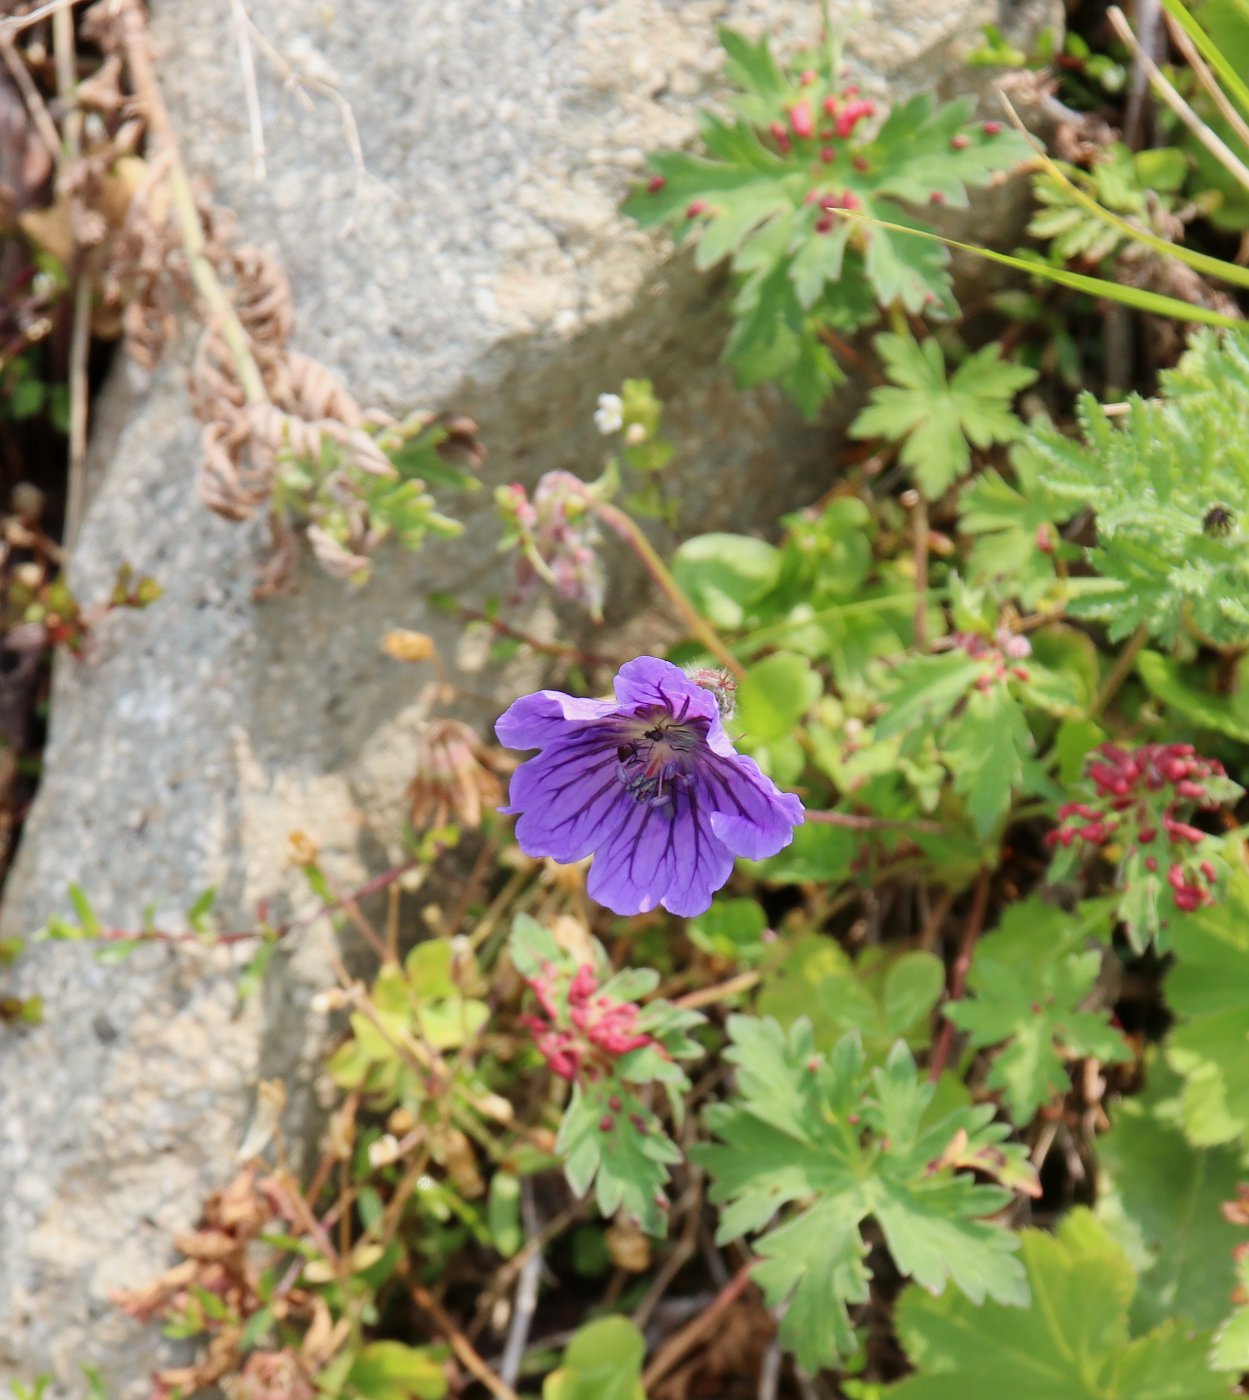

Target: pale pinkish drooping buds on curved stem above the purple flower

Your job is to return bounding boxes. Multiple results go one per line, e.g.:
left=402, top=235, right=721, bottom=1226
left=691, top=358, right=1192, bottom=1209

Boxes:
left=504, top=472, right=606, bottom=617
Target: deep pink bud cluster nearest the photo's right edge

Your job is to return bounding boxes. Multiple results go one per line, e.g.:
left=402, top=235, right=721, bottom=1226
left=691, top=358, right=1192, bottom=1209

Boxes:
left=1046, top=743, right=1225, bottom=913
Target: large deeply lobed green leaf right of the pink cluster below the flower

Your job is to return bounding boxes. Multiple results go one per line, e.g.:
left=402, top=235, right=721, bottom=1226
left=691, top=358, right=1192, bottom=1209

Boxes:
left=692, top=1016, right=1026, bottom=1371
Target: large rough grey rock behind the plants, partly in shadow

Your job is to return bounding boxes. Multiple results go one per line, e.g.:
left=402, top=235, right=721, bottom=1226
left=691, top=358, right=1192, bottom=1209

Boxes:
left=0, top=0, right=1053, bottom=1396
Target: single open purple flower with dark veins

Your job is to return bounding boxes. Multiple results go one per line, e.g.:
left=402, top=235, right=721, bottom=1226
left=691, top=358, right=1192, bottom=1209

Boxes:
left=494, top=657, right=802, bottom=914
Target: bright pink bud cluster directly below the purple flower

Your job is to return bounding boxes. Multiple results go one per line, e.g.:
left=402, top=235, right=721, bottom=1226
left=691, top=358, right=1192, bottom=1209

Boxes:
left=521, top=962, right=658, bottom=1082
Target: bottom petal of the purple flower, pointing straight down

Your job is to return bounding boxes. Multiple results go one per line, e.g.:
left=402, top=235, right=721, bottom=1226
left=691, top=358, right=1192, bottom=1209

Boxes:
left=585, top=787, right=732, bottom=917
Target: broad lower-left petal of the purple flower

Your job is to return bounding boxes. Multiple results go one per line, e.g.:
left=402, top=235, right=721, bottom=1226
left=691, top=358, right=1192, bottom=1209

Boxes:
left=500, top=727, right=637, bottom=864
